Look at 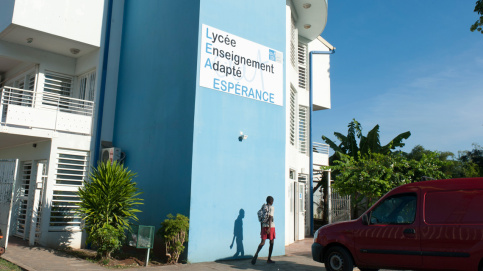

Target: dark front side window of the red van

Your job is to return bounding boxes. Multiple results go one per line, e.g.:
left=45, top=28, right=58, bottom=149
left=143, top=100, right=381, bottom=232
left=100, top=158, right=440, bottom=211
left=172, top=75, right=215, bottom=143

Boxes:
left=370, top=193, right=417, bottom=225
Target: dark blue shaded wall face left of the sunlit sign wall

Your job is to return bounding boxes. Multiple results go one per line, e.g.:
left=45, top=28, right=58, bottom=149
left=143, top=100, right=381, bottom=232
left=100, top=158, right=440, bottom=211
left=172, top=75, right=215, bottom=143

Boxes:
left=113, top=0, right=199, bottom=228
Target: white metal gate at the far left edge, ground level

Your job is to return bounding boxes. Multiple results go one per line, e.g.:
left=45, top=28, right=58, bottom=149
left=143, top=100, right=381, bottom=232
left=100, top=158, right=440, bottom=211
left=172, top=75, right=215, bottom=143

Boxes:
left=0, top=160, right=18, bottom=251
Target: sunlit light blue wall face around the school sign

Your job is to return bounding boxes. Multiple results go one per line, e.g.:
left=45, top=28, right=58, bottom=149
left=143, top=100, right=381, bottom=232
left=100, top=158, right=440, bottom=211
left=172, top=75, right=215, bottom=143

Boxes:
left=188, top=0, right=285, bottom=262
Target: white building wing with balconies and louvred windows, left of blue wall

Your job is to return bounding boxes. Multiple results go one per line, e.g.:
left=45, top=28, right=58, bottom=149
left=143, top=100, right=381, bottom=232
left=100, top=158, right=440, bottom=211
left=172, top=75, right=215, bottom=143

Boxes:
left=0, top=0, right=104, bottom=251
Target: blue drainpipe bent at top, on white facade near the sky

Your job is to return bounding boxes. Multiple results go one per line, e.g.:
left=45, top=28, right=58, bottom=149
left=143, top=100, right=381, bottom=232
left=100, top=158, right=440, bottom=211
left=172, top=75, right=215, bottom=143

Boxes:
left=309, top=48, right=335, bottom=234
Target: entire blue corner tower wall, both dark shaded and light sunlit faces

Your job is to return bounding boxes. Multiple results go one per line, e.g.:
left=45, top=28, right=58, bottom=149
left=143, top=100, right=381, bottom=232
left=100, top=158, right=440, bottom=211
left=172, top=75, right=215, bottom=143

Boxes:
left=105, top=0, right=285, bottom=262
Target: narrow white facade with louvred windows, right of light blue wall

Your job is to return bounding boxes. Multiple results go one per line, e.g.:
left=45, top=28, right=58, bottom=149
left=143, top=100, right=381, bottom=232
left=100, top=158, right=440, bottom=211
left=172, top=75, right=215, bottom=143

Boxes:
left=285, top=1, right=335, bottom=245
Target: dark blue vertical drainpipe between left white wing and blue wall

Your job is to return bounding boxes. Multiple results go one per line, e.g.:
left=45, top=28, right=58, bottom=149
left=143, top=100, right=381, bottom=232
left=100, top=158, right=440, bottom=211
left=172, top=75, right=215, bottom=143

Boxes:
left=94, top=0, right=113, bottom=163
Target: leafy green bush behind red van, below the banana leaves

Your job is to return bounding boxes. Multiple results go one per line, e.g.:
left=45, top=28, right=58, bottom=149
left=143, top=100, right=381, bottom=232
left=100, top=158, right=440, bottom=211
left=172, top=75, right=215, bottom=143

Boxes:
left=325, top=152, right=446, bottom=217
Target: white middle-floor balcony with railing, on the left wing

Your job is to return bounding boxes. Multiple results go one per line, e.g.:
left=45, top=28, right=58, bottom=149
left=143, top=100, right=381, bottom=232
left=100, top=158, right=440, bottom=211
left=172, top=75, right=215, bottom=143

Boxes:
left=0, top=87, right=94, bottom=136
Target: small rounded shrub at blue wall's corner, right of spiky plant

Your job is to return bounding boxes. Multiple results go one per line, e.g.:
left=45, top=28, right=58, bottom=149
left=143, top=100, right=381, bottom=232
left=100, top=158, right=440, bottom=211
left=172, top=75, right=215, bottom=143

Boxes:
left=158, top=214, right=189, bottom=263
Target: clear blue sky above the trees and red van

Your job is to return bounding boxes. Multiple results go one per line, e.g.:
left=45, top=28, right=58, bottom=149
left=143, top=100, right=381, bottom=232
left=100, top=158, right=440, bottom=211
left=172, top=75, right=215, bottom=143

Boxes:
left=312, top=0, right=483, bottom=155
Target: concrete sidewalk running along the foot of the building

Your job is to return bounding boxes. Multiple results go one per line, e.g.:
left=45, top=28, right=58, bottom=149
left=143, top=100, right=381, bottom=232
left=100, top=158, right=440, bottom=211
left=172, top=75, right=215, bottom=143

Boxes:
left=2, top=237, right=325, bottom=271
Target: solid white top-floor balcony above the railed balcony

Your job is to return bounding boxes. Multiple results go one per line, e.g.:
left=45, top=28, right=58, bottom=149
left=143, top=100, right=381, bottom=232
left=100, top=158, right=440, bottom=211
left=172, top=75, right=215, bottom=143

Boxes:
left=0, top=0, right=104, bottom=58
